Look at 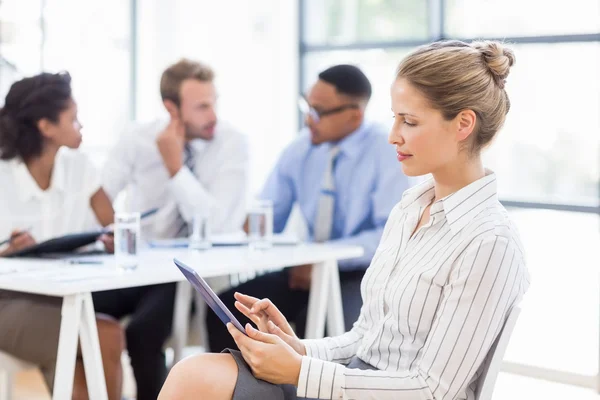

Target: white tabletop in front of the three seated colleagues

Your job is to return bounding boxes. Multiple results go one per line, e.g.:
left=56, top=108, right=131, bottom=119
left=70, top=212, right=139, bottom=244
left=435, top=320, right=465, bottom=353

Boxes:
left=0, top=244, right=363, bottom=297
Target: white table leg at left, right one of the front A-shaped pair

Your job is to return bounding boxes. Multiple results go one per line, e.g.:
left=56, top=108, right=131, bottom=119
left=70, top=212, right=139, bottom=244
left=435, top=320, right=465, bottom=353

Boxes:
left=79, top=293, right=108, bottom=400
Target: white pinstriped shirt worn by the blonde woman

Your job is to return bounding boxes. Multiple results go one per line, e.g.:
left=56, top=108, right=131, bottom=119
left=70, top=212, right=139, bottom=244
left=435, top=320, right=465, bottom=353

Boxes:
left=298, top=171, right=529, bottom=400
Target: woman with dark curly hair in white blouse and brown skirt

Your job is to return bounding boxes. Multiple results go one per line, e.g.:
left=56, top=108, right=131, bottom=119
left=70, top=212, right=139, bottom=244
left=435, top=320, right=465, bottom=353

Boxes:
left=0, top=73, right=124, bottom=399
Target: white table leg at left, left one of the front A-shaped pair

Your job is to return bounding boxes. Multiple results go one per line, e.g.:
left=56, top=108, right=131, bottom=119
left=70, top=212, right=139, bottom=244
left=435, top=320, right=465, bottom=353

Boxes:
left=52, top=295, right=83, bottom=400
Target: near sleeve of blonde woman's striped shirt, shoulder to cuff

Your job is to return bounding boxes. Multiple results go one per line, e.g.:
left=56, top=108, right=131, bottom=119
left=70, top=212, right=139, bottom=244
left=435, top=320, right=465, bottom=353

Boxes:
left=298, top=236, right=527, bottom=400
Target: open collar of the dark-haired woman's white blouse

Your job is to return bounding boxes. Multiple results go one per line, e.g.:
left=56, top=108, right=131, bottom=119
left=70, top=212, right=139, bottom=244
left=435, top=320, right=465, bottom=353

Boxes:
left=10, top=152, right=65, bottom=202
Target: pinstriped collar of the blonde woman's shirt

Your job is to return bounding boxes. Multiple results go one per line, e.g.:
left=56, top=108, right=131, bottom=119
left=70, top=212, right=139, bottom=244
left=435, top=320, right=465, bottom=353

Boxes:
left=400, top=170, right=498, bottom=233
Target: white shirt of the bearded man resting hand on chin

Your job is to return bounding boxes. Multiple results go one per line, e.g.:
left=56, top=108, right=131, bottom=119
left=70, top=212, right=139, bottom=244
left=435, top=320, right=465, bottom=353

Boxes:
left=102, top=120, right=249, bottom=239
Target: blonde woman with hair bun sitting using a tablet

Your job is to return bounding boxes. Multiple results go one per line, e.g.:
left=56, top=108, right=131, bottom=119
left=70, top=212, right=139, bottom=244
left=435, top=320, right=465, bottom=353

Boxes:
left=159, top=41, right=529, bottom=400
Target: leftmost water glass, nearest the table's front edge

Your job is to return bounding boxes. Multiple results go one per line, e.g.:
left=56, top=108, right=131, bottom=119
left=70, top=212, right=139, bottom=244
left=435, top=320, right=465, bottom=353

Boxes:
left=115, top=212, right=140, bottom=271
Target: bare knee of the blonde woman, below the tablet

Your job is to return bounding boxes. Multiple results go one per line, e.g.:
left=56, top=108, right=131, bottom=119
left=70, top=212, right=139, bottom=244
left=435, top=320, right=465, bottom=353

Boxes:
left=159, top=353, right=238, bottom=400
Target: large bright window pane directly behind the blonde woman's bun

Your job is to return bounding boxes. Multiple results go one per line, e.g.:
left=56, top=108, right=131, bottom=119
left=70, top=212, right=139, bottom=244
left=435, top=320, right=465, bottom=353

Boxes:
left=487, top=42, right=600, bottom=206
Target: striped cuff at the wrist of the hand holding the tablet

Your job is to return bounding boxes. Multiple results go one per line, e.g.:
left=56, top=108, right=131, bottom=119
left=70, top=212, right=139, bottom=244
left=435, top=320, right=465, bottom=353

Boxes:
left=297, top=357, right=346, bottom=399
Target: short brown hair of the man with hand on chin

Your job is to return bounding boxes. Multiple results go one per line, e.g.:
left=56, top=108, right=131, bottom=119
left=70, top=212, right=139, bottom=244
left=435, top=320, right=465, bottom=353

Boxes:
left=160, top=58, right=215, bottom=106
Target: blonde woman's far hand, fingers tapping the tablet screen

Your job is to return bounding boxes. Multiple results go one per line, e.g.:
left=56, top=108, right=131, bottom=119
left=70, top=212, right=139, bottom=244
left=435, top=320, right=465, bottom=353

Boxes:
left=234, top=293, right=306, bottom=356
